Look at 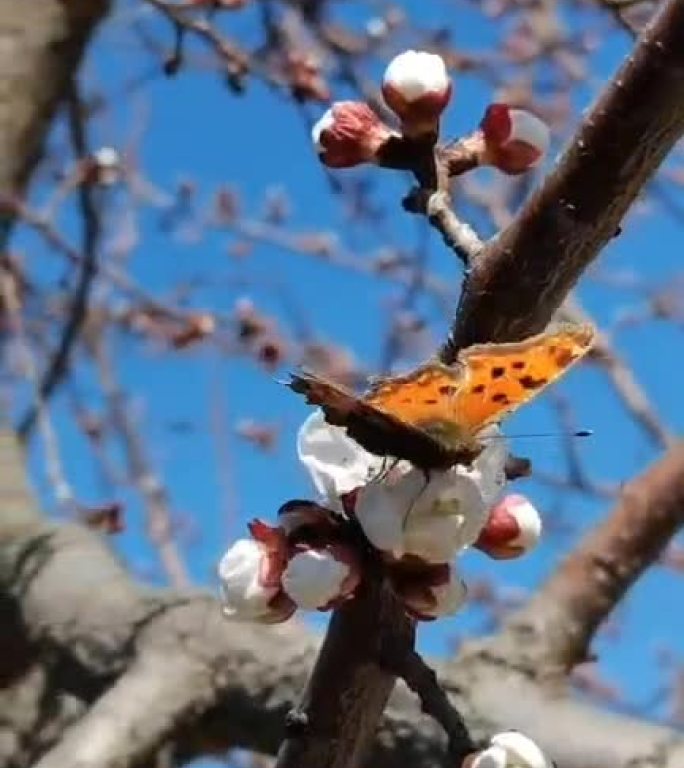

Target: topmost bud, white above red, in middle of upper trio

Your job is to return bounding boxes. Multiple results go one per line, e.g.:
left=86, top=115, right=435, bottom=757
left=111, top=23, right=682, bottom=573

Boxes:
left=382, top=51, right=451, bottom=137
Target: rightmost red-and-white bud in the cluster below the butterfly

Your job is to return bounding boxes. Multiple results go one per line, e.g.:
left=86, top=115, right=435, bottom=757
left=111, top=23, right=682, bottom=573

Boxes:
left=474, top=494, right=542, bottom=560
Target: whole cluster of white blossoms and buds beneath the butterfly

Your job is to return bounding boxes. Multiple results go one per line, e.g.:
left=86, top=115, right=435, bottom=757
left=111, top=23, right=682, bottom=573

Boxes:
left=219, top=411, right=541, bottom=623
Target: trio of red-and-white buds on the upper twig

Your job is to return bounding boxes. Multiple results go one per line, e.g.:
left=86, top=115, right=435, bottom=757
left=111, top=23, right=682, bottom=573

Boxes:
left=312, top=51, right=550, bottom=175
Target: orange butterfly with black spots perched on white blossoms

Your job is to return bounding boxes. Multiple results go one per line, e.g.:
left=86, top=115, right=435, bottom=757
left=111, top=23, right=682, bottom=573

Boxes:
left=288, top=325, right=595, bottom=471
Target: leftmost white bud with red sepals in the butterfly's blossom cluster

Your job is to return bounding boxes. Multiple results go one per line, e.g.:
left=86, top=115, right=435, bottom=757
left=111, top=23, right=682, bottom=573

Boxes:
left=218, top=520, right=296, bottom=624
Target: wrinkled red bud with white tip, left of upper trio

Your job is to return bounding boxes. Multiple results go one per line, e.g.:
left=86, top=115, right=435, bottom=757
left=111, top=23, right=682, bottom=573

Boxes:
left=311, top=101, right=392, bottom=168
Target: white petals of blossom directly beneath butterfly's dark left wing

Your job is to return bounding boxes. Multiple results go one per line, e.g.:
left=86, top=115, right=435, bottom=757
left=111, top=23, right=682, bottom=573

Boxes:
left=297, top=410, right=383, bottom=506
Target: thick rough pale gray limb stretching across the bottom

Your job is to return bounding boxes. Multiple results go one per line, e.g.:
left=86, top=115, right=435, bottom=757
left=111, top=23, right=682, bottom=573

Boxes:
left=0, top=437, right=684, bottom=768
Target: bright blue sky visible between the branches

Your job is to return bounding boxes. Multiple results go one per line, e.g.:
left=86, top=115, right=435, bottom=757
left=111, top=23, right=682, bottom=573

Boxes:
left=17, top=2, right=684, bottom=748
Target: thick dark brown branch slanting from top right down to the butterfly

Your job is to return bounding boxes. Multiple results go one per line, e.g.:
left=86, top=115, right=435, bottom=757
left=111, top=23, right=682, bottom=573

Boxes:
left=442, top=0, right=684, bottom=361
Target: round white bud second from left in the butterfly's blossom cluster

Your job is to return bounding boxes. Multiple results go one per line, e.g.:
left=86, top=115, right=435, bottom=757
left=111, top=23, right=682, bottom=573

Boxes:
left=282, top=544, right=361, bottom=610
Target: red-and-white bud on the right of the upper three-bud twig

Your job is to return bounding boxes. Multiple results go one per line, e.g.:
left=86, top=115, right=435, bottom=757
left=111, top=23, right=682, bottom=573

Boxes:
left=480, top=104, right=551, bottom=175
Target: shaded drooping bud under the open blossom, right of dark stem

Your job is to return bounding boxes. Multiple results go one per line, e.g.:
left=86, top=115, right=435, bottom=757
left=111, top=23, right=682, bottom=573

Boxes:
left=389, top=558, right=467, bottom=621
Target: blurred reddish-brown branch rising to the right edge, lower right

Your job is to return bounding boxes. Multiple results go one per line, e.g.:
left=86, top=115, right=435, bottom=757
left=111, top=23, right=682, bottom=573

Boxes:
left=494, top=443, right=684, bottom=675
